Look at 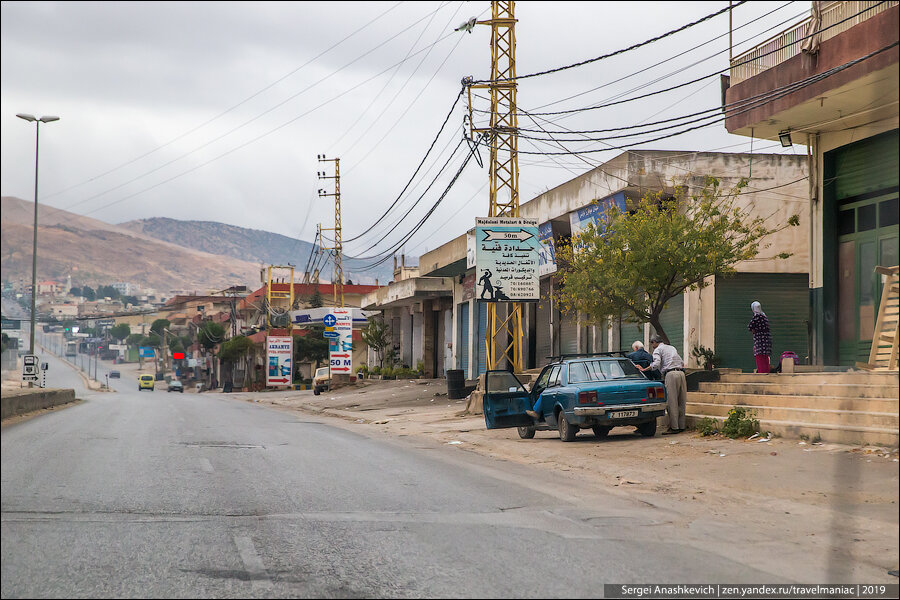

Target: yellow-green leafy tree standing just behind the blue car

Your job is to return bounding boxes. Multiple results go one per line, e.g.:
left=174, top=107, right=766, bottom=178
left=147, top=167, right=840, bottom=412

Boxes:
left=555, top=177, right=800, bottom=341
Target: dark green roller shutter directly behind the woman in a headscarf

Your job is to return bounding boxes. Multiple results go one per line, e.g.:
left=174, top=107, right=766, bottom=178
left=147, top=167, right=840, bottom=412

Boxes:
left=715, top=273, right=809, bottom=373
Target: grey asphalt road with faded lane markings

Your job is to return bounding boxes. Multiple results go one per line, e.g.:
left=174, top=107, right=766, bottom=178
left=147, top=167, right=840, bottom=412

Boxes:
left=0, top=358, right=782, bottom=598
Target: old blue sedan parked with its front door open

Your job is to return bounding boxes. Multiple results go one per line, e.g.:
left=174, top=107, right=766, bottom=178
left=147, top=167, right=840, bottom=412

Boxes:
left=484, top=356, right=666, bottom=442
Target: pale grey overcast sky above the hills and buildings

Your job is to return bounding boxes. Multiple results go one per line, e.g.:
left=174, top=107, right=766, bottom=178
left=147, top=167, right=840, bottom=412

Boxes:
left=0, top=1, right=809, bottom=260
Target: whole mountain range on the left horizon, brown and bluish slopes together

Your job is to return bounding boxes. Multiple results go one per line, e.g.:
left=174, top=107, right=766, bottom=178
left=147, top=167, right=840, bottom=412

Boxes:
left=0, top=196, right=393, bottom=293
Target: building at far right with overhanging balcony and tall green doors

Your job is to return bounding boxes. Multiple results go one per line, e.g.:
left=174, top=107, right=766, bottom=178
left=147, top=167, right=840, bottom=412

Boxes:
left=724, top=2, right=900, bottom=365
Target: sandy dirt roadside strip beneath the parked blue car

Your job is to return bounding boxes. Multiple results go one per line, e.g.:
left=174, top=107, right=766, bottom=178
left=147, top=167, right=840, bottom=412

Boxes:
left=223, top=380, right=900, bottom=581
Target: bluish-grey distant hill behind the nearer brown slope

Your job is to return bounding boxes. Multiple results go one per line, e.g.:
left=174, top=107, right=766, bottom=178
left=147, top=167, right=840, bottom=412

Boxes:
left=119, top=217, right=393, bottom=284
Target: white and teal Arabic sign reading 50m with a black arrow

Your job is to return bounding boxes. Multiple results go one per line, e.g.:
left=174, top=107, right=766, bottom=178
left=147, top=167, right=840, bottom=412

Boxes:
left=475, top=217, right=541, bottom=302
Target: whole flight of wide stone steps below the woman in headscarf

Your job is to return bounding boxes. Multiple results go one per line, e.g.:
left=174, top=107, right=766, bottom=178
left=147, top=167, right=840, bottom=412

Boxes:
left=687, top=371, right=900, bottom=446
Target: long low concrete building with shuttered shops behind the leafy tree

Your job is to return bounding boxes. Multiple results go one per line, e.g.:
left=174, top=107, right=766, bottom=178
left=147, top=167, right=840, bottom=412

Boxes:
left=363, top=150, right=809, bottom=379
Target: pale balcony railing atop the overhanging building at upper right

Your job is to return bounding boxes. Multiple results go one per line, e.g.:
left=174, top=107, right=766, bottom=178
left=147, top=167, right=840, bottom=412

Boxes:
left=731, top=0, right=900, bottom=85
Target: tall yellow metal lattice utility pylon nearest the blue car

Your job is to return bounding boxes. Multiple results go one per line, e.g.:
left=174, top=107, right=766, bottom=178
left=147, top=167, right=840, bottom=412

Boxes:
left=467, top=0, right=525, bottom=373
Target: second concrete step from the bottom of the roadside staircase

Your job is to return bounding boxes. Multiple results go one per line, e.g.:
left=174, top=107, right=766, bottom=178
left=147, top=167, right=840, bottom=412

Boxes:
left=687, top=402, right=900, bottom=433
